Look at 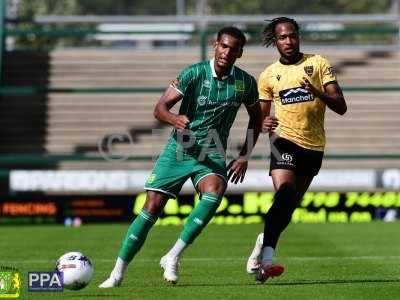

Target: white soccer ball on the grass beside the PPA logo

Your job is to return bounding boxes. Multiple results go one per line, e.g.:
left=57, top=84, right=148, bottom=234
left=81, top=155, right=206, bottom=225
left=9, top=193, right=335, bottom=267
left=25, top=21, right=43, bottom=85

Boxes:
left=56, top=252, right=94, bottom=290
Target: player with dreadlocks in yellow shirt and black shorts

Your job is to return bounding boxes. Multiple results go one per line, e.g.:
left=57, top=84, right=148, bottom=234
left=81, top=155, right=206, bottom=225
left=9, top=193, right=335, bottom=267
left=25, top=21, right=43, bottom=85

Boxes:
left=247, top=17, right=347, bottom=283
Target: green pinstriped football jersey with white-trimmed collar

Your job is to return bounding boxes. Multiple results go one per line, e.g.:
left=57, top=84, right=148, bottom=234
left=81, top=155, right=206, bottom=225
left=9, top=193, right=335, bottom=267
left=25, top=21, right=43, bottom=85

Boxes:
left=171, top=59, right=258, bottom=151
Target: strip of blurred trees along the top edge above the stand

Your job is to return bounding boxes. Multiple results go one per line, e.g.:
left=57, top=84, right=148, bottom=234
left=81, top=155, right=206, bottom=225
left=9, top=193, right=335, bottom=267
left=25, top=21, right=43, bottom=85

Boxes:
left=14, top=0, right=391, bottom=16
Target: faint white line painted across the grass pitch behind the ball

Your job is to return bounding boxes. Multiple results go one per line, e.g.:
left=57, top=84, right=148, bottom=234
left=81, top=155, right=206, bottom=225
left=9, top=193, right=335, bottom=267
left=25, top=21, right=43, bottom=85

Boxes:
left=0, top=256, right=400, bottom=268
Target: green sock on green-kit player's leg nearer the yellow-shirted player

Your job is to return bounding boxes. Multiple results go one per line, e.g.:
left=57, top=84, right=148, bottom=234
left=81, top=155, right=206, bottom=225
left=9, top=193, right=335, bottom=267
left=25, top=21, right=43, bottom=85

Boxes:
left=180, top=193, right=222, bottom=244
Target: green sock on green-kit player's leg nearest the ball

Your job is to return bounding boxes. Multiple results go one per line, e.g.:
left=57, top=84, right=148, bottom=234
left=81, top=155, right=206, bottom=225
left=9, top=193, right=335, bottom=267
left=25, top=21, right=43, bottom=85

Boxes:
left=118, top=209, right=158, bottom=263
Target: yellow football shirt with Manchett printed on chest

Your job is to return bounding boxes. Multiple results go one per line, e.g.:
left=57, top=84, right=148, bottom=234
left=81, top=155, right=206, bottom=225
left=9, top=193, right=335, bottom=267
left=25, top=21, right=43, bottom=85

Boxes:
left=258, top=54, right=336, bottom=151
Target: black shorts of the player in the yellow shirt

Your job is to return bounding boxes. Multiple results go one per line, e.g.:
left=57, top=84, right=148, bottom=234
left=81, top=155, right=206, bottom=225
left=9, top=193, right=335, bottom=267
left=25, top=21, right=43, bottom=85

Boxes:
left=269, top=137, right=324, bottom=176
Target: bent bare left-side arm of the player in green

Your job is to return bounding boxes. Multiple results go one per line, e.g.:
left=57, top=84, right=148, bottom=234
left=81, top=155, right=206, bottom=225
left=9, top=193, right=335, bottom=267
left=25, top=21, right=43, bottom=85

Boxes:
left=153, top=87, right=189, bottom=130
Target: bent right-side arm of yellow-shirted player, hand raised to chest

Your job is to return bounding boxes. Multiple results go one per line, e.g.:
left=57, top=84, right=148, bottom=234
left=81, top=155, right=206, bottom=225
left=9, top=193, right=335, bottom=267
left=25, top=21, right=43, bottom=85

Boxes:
left=300, top=77, right=347, bottom=115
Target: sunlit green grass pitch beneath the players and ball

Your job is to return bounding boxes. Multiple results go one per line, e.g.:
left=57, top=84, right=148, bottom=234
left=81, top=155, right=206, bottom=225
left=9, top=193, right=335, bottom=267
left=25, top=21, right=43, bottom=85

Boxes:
left=0, top=222, right=400, bottom=300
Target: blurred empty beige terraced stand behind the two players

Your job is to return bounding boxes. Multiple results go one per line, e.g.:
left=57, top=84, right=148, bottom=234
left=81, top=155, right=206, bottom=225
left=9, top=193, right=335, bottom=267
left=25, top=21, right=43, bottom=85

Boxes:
left=0, top=47, right=400, bottom=169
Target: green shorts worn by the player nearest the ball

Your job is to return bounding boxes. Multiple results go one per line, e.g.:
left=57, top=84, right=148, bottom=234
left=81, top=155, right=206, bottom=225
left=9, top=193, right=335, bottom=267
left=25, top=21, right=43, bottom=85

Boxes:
left=144, top=138, right=227, bottom=198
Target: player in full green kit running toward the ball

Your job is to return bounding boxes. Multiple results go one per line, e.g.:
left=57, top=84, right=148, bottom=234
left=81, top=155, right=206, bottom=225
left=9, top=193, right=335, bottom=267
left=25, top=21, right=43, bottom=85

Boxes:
left=99, top=27, right=261, bottom=288
